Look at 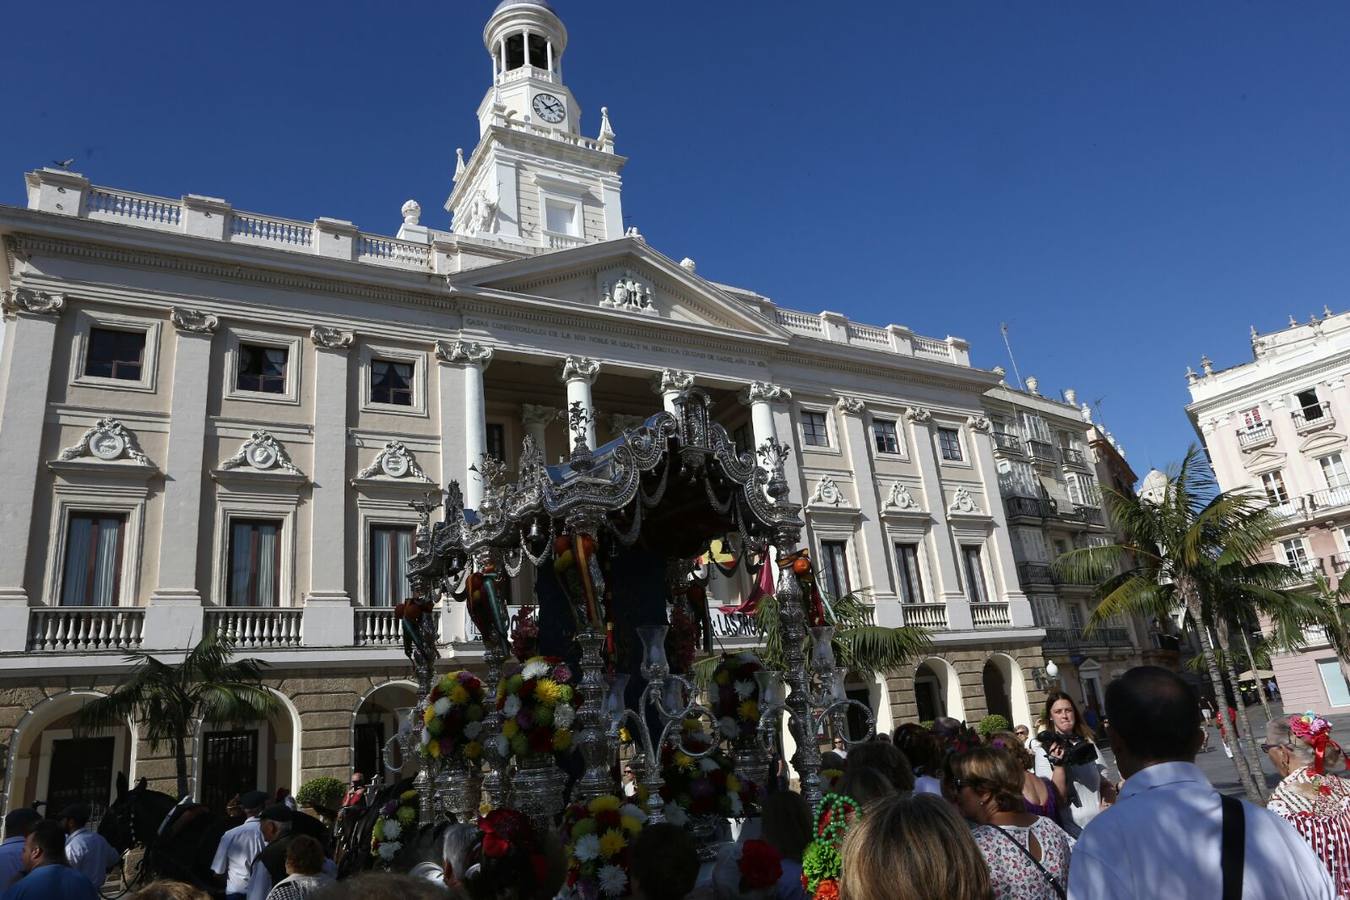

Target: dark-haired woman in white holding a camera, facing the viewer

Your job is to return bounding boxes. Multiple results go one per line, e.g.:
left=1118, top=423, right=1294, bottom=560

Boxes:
left=1031, top=691, right=1116, bottom=838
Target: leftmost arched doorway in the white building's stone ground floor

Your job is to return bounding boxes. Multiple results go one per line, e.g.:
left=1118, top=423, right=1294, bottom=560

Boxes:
left=5, top=691, right=136, bottom=819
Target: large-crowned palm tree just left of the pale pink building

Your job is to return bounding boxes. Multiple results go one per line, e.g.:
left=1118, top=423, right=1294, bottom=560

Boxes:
left=1054, top=445, right=1288, bottom=803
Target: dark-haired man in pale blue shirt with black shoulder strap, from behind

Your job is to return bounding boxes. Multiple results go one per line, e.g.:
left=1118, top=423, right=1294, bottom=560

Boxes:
left=1069, top=665, right=1335, bottom=900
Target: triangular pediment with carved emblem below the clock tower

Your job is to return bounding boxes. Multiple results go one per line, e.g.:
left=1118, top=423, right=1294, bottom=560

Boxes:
left=450, top=237, right=788, bottom=340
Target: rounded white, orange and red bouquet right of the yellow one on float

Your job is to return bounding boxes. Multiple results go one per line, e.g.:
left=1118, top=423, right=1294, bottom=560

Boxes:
left=497, top=656, right=576, bottom=758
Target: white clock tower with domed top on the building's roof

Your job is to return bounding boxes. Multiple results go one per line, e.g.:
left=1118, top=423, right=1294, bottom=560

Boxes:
left=446, top=0, right=628, bottom=250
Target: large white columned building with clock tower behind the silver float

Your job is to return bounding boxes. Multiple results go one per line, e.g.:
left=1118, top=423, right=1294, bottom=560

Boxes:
left=0, top=0, right=1044, bottom=808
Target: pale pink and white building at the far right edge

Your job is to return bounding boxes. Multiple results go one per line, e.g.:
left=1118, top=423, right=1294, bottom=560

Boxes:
left=1187, top=309, right=1350, bottom=712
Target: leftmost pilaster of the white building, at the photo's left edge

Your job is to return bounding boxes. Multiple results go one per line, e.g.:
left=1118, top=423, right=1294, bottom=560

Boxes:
left=0, top=287, right=66, bottom=650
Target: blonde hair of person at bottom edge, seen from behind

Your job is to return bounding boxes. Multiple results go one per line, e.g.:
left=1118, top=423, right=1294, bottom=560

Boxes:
left=840, top=793, right=994, bottom=900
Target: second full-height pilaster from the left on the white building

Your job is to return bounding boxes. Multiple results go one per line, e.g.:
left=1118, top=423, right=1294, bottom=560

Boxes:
left=142, top=306, right=217, bottom=650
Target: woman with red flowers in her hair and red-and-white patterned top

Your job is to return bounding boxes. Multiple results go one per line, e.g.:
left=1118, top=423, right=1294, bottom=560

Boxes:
left=1261, top=712, right=1350, bottom=900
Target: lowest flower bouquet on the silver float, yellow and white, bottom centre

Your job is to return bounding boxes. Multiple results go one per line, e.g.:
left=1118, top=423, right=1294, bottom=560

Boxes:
left=563, top=795, right=647, bottom=900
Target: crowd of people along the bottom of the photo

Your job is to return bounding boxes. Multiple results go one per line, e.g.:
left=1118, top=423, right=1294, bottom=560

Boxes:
left=0, top=667, right=1350, bottom=900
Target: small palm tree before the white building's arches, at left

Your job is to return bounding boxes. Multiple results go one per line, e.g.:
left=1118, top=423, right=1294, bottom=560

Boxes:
left=77, top=631, right=277, bottom=797
